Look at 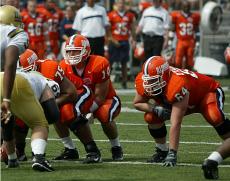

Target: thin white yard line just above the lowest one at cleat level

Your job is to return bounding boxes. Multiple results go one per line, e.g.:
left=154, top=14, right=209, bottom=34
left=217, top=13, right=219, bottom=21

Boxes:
left=26, top=138, right=221, bottom=145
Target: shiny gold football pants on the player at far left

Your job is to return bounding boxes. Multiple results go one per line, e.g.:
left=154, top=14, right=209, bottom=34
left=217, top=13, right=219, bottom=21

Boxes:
left=0, top=73, right=48, bottom=129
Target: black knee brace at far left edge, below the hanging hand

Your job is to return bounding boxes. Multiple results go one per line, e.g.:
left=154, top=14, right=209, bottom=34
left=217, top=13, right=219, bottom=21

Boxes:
left=1, top=116, right=15, bottom=141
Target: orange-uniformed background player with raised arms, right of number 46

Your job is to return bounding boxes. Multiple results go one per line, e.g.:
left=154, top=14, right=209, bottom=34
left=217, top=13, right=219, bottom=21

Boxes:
left=37, top=0, right=64, bottom=57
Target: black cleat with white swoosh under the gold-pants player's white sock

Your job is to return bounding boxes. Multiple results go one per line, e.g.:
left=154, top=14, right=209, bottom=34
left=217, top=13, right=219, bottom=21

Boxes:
left=32, top=154, right=54, bottom=172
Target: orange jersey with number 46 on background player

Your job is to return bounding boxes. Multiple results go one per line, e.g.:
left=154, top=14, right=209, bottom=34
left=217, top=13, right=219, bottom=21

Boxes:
left=21, top=11, right=46, bottom=44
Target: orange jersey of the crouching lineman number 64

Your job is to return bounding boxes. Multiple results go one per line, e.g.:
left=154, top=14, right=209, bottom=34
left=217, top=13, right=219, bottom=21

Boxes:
left=135, top=67, right=220, bottom=109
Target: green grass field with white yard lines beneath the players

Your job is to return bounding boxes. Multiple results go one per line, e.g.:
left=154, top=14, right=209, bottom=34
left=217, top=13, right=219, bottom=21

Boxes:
left=1, top=79, right=230, bottom=181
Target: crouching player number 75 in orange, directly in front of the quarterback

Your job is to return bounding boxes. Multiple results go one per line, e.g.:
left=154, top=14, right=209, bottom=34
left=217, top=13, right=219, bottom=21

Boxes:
left=17, top=49, right=100, bottom=161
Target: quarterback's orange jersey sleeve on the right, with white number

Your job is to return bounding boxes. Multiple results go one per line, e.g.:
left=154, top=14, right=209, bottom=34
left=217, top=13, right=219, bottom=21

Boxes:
left=93, top=57, right=110, bottom=84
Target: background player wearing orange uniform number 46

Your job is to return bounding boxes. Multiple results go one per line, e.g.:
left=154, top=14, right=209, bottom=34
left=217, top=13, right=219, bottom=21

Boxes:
left=21, top=0, right=46, bottom=59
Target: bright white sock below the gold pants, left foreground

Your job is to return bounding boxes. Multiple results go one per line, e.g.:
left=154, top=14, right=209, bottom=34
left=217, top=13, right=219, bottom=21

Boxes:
left=31, top=138, right=46, bottom=155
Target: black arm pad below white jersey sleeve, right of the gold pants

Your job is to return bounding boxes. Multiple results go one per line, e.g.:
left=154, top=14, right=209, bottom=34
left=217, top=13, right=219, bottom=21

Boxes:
left=41, top=98, right=60, bottom=124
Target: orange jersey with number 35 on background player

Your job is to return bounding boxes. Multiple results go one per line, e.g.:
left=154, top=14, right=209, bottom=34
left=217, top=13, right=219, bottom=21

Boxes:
left=108, top=11, right=135, bottom=41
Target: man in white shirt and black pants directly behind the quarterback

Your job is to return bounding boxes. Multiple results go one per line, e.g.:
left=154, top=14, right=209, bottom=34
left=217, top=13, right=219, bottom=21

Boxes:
left=73, top=0, right=110, bottom=56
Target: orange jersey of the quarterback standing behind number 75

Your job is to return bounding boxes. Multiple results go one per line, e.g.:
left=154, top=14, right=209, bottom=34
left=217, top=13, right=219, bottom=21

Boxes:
left=60, top=55, right=116, bottom=99
